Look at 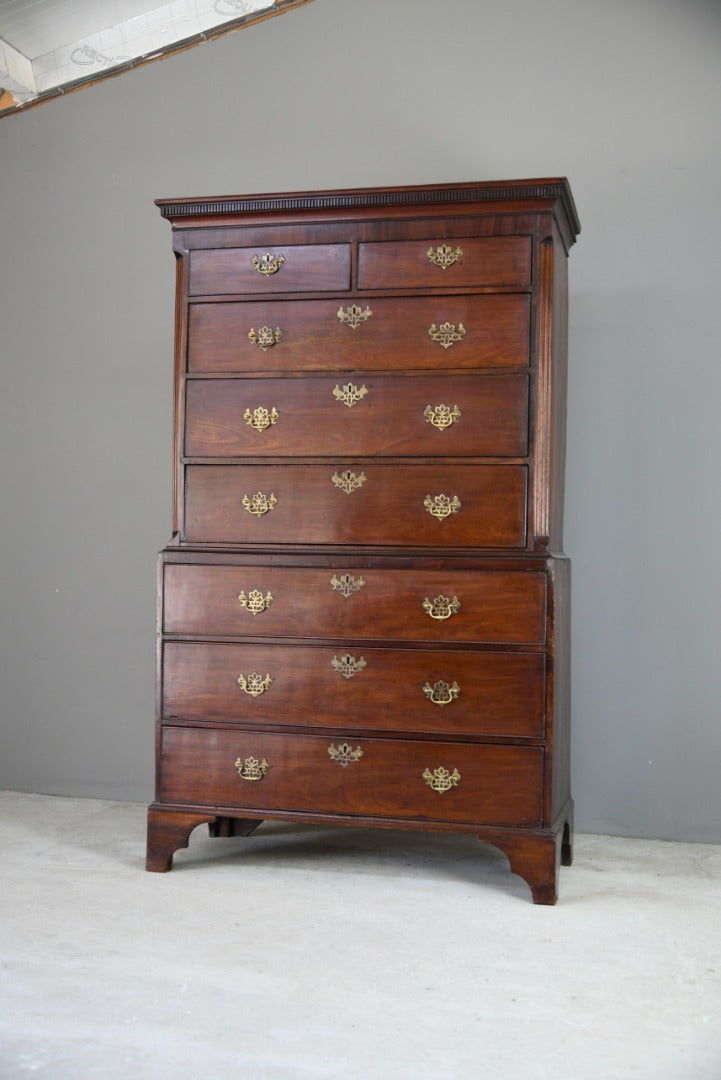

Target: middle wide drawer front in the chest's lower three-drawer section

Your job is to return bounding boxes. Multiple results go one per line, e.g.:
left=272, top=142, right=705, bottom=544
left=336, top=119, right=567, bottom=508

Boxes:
left=163, top=642, right=545, bottom=738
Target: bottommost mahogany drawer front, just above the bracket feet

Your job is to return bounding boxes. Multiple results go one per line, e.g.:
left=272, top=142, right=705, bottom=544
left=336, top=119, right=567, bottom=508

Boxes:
left=161, top=728, right=543, bottom=825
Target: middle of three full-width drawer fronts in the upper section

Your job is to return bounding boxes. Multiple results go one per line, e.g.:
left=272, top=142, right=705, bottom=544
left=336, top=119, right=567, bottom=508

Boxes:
left=186, top=375, right=528, bottom=457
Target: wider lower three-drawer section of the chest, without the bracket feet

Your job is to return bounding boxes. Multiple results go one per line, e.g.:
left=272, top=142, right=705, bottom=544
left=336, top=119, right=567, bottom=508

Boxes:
left=159, top=552, right=558, bottom=826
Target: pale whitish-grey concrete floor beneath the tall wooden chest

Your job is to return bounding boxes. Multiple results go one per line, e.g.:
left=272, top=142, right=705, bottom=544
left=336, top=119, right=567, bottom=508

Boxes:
left=0, top=793, right=721, bottom=1080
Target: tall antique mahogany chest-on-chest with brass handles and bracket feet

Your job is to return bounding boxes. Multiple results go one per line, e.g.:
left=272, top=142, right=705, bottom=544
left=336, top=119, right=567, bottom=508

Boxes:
left=147, top=179, right=579, bottom=904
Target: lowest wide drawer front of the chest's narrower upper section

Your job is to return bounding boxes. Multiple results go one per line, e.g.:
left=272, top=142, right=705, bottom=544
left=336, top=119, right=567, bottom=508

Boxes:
left=183, top=460, right=527, bottom=548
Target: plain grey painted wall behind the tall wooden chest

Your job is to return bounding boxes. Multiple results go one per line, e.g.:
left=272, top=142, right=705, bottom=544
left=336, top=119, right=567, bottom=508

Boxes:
left=0, top=0, right=721, bottom=841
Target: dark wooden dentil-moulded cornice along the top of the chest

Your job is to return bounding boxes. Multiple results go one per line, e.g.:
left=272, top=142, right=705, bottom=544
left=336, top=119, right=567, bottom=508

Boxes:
left=155, top=177, right=581, bottom=239
